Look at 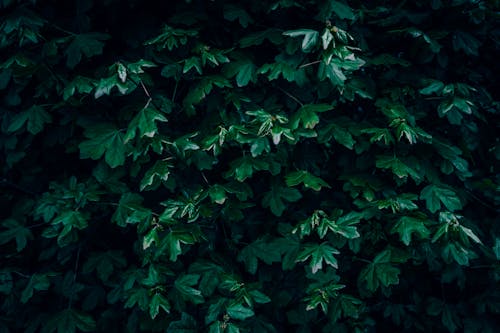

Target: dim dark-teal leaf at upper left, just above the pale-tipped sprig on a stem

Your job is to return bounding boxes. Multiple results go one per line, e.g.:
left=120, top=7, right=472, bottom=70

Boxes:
left=65, top=33, right=110, bottom=68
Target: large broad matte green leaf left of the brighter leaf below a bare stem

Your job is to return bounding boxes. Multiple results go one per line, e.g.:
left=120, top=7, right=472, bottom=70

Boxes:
left=78, top=124, right=125, bottom=168
